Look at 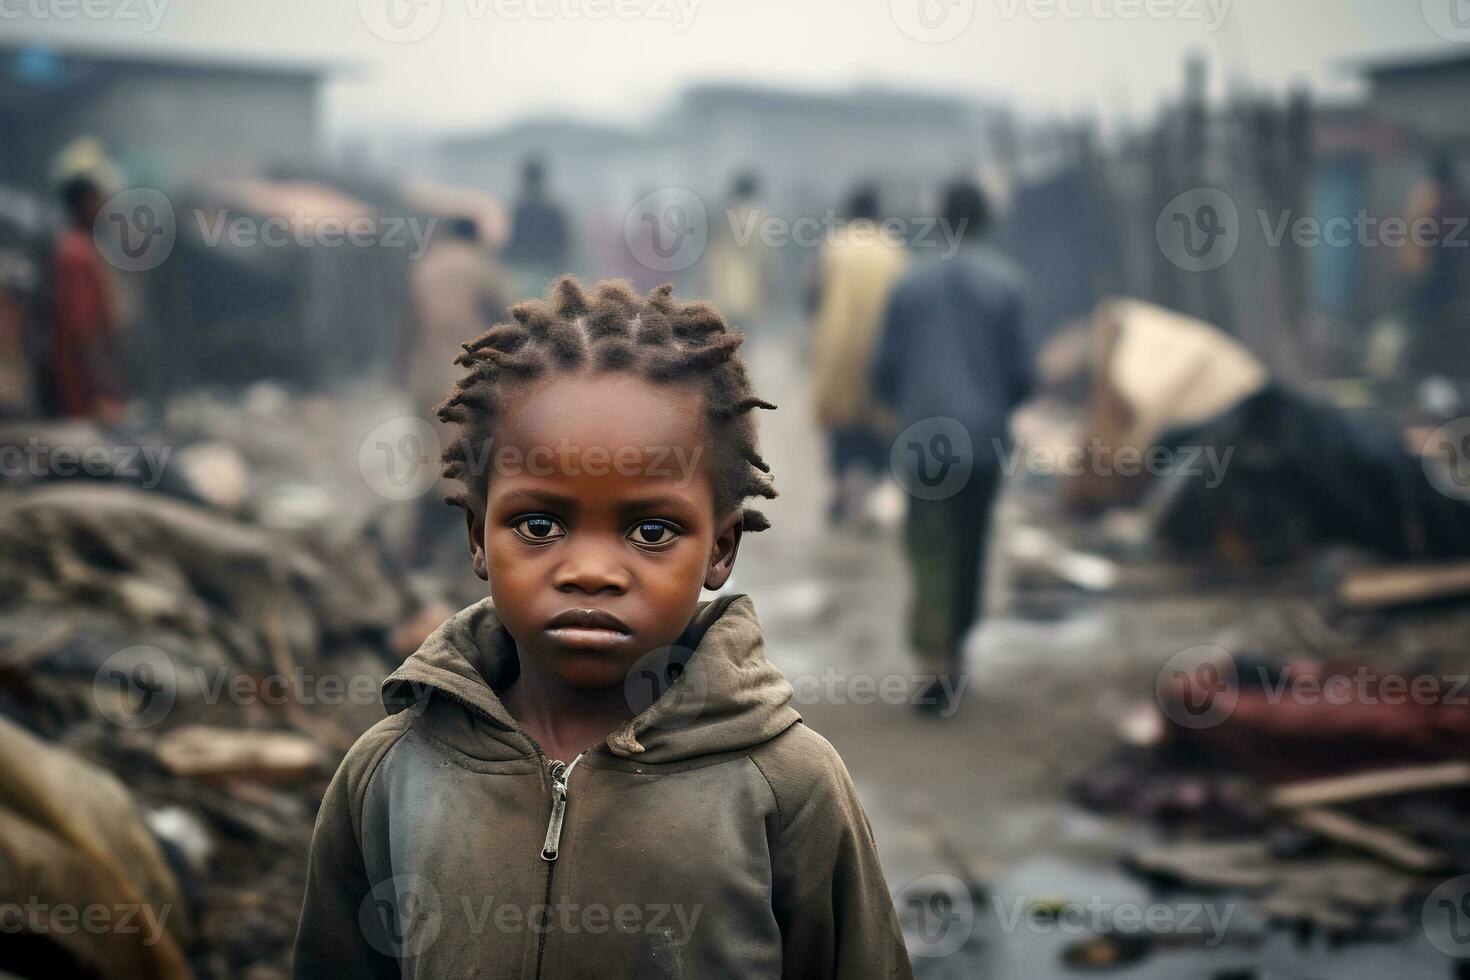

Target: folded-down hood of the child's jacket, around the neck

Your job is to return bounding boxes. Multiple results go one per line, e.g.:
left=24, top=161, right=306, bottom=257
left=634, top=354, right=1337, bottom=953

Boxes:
left=373, top=595, right=801, bottom=763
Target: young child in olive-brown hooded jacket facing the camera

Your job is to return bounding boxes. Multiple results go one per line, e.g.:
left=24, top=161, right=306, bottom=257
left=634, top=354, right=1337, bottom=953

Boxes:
left=295, top=278, right=911, bottom=979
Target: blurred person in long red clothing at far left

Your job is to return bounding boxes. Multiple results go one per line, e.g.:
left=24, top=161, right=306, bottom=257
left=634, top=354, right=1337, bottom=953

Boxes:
left=49, top=176, right=123, bottom=423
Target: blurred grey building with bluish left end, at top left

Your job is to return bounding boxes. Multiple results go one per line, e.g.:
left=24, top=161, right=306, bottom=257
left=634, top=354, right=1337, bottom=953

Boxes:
left=0, top=43, right=323, bottom=190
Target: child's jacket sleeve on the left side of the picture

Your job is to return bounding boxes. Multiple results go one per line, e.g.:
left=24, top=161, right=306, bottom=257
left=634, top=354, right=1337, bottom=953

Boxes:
left=291, top=724, right=400, bottom=980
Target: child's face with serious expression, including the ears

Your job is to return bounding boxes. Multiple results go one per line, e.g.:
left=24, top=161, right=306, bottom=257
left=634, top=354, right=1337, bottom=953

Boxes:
left=470, top=373, right=741, bottom=688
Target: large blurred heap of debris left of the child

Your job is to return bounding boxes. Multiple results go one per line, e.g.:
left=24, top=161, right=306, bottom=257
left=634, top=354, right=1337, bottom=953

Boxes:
left=0, top=402, right=429, bottom=980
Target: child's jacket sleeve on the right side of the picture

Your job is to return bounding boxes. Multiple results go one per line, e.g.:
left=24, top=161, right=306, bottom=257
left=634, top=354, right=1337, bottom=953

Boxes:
left=757, top=723, right=913, bottom=980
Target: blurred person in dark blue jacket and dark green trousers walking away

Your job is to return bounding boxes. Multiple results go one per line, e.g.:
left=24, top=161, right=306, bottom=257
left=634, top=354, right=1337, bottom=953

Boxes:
left=873, top=182, right=1033, bottom=716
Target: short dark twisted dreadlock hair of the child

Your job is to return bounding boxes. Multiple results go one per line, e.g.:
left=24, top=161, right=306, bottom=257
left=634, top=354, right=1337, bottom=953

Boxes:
left=435, top=276, right=776, bottom=530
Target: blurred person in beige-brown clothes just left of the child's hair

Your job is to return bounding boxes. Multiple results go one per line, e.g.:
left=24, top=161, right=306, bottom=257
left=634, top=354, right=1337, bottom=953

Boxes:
left=406, top=217, right=510, bottom=567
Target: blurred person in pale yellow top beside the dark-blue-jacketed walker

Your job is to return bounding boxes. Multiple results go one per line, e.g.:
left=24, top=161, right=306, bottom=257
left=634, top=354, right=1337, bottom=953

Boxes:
left=810, top=185, right=908, bottom=526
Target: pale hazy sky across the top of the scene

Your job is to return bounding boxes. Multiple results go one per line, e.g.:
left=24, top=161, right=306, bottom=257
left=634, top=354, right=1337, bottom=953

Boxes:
left=0, top=0, right=1470, bottom=132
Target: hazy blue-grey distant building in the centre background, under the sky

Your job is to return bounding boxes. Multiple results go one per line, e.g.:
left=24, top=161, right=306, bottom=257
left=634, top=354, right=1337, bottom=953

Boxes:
left=435, top=85, right=1011, bottom=294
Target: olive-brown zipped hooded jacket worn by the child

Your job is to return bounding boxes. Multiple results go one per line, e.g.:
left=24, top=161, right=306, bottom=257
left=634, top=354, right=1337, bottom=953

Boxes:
left=295, top=597, right=911, bottom=979
